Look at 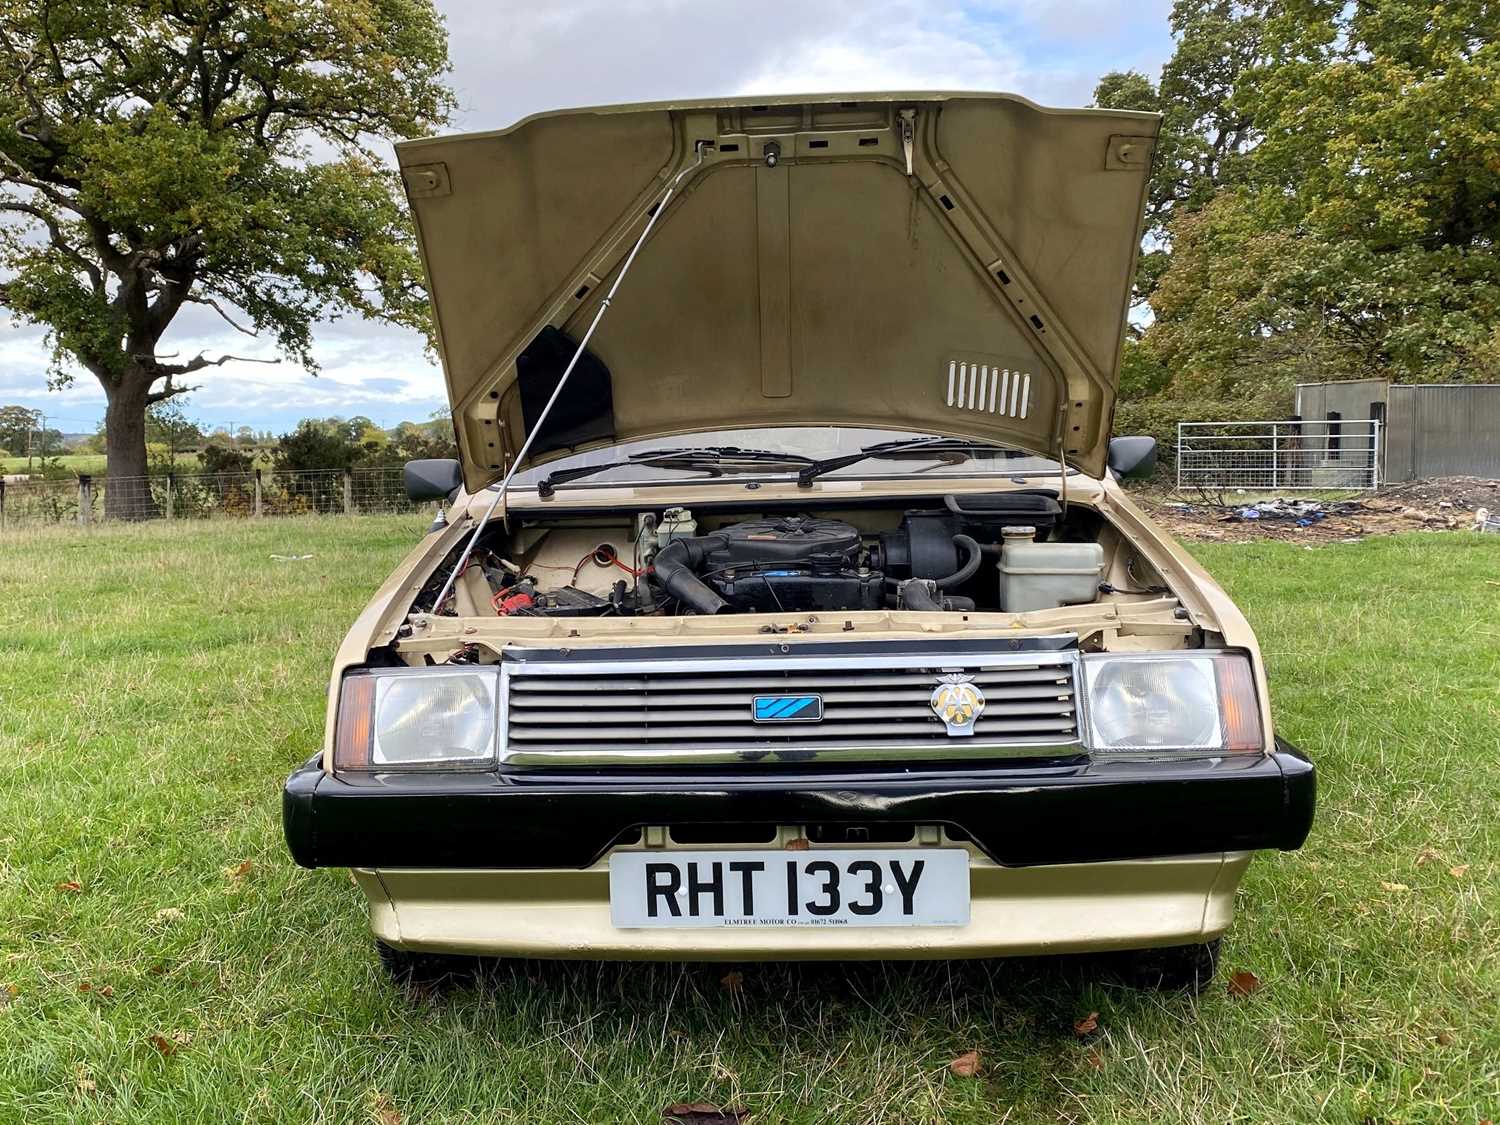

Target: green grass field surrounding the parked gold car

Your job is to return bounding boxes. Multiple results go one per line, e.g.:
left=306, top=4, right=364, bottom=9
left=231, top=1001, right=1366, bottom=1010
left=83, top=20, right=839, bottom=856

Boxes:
left=0, top=519, right=1500, bottom=1125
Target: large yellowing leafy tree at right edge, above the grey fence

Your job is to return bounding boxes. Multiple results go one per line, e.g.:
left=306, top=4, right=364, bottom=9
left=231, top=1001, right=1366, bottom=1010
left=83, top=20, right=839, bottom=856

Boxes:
left=1151, top=0, right=1500, bottom=387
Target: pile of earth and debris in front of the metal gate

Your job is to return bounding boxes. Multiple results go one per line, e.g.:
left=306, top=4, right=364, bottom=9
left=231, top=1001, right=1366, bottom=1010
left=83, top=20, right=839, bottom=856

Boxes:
left=1145, top=477, right=1500, bottom=543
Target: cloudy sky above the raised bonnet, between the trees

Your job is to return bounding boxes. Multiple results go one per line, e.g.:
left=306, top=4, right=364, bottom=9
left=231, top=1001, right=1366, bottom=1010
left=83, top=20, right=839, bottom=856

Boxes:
left=440, top=0, right=1128, bottom=129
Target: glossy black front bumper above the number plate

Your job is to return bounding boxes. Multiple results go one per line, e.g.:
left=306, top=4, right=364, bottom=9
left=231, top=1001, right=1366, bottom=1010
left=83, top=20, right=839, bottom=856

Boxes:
left=282, top=740, right=1317, bottom=869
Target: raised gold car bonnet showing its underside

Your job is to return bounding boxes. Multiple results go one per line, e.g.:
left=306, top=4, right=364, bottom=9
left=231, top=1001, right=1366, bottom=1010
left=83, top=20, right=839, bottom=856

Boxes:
left=398, top=93, right=1158, bottom=491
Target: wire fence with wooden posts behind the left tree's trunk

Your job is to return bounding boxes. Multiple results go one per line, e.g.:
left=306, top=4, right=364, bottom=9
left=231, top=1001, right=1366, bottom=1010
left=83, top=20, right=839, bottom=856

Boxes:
left=0, top=468, right=431, bottom=531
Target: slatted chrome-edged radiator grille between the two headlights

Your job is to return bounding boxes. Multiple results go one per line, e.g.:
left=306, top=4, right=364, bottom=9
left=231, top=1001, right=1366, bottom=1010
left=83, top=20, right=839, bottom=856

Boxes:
left=501, top=651, right=1079, bottom=767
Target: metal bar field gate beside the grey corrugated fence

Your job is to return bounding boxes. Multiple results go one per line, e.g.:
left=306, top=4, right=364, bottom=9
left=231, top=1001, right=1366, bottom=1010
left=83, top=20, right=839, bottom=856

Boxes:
left=1178, top=417, right=1380, bottom=492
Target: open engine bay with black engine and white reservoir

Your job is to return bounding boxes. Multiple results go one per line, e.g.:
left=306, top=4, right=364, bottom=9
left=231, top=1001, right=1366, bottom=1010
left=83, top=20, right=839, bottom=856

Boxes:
left=416, top=489, right=1167, bottom=618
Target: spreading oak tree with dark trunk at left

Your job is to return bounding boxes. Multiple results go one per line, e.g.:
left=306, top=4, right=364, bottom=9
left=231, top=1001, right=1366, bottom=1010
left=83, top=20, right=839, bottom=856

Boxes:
left=0, top=0, right=453, bottom=515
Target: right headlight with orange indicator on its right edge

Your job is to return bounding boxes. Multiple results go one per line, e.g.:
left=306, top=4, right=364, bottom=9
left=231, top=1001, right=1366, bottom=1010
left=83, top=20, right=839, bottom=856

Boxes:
left=1083, top=653, right=1263, bottom=752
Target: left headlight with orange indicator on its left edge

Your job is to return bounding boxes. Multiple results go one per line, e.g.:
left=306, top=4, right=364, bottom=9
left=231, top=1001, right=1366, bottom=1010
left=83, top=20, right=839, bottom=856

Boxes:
left=333, top=665, right=500, bottom=770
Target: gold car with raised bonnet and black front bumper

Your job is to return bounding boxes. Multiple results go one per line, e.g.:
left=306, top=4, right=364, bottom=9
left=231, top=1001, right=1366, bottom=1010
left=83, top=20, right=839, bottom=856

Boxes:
left=284, top=93, right=1314, bottom=986
